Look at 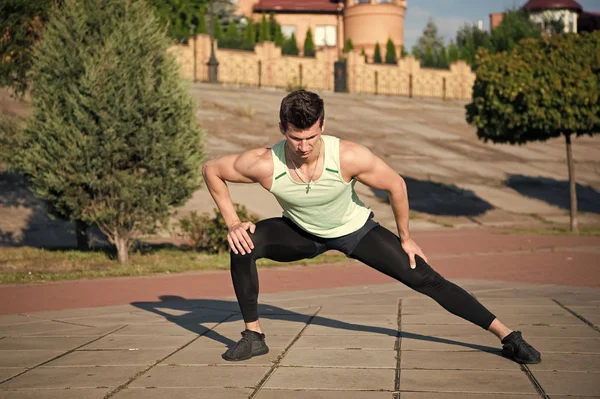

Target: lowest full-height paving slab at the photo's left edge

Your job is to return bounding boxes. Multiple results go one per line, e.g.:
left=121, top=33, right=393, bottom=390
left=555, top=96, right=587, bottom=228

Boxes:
left=2, top=366, right=144, bottom=388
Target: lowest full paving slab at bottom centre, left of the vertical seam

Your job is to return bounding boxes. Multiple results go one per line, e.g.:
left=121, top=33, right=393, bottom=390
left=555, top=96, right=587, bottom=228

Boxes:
left=264, top=367, right=396, bottom=390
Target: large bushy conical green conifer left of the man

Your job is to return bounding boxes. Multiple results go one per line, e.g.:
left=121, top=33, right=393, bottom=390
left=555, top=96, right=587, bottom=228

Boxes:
left=19, top=0, right=203, bottom=262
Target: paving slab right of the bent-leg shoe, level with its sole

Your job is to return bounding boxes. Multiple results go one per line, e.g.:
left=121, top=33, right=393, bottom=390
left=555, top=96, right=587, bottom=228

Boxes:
left=281, top=347, right=397, bottom=368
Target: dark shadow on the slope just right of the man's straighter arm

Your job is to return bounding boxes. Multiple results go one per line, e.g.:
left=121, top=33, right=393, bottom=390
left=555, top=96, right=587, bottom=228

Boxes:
left=372, top=177, right=494, bottom=217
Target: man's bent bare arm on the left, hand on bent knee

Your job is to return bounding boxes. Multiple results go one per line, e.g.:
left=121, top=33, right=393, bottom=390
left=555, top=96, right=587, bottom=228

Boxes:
left=202, top=148, right=273, bottom=229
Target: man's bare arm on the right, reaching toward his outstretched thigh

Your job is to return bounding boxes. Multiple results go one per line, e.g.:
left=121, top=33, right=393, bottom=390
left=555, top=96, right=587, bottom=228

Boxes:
left=340, top=141, right=410, bottom=242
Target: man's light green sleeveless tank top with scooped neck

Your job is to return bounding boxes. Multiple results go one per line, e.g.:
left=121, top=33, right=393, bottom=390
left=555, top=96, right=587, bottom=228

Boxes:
left=270, top=135, right=371, bottom=238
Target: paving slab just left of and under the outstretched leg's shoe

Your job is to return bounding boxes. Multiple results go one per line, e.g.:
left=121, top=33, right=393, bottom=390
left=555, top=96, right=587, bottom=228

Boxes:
left=400, top=351, right=519, bottom=370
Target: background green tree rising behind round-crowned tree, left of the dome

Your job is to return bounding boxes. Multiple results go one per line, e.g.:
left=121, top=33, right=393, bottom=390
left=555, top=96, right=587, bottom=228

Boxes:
left=490, top=10, right=542, bottom=53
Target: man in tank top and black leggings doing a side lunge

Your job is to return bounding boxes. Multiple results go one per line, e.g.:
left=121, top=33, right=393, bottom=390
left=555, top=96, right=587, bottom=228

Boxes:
left=203, top=90, right=541, bottom=363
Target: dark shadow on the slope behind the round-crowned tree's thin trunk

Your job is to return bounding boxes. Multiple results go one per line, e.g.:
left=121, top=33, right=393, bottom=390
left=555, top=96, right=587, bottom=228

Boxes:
left=505, top=175, right=600, bottom=213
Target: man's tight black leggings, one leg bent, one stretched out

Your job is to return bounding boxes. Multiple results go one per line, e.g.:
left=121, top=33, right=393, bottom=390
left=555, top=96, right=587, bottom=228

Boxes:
left=231, top=218, right=496, bottom=330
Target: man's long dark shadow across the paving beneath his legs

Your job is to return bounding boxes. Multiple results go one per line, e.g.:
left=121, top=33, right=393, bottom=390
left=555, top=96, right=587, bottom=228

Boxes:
left=131, top=295, right=502, bottom=356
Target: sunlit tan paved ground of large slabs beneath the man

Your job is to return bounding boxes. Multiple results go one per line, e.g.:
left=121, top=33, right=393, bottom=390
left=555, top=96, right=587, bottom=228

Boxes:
left=0, top=280, right=600, bottom=399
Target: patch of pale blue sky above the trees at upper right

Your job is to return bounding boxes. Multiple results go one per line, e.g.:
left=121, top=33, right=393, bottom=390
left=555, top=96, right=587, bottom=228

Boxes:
left=404, top=0, right=600, bottom=51
